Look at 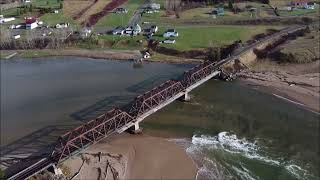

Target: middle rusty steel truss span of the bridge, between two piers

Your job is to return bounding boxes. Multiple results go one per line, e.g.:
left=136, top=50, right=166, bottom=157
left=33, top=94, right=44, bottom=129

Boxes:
left=129, top=80, right=184, bottom=117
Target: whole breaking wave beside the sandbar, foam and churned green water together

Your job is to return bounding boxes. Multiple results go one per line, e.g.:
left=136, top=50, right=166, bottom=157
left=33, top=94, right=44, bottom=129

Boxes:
left=170, top=132, right=314, bottom=180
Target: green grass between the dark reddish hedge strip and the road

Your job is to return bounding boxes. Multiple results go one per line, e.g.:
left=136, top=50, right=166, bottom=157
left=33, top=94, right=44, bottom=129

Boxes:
left=95, top=0, right=144, bottom=27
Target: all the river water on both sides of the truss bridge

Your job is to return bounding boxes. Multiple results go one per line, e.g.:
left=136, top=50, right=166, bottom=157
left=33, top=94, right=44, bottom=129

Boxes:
left=1, top=57, right=320, bottom=179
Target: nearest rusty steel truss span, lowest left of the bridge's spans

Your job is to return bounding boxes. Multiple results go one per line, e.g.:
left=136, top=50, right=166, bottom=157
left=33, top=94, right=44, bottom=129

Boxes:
left=51, top=108, right=133, bottom=162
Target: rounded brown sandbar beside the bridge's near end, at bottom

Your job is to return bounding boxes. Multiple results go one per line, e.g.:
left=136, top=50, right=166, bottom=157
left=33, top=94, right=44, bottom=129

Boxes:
left=64, top=133, right=197, bottom=179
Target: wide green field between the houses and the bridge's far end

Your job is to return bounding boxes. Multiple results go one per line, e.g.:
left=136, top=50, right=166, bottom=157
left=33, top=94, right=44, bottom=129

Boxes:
left=155, top=26, right=281, bottom=50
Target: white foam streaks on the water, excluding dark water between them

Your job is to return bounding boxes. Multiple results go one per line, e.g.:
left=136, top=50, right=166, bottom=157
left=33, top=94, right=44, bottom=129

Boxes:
left=171, top=132, right=311, bottom=180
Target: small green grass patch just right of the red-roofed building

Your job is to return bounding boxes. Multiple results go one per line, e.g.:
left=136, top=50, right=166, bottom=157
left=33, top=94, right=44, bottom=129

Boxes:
left=40, top=11, right=78, bottom=26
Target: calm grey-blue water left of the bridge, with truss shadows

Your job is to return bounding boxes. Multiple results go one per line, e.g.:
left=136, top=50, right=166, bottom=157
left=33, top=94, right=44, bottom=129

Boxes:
left=1, top=57, right=191, bottom=146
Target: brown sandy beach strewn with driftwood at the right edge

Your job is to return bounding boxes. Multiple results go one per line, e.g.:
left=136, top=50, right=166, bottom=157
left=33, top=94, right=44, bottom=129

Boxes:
left=238, top=60, right=320, bottom=112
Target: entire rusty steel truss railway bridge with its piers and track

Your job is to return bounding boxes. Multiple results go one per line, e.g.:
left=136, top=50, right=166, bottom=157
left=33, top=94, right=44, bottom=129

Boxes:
left=4, top=26, right=305, bottom=179
